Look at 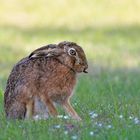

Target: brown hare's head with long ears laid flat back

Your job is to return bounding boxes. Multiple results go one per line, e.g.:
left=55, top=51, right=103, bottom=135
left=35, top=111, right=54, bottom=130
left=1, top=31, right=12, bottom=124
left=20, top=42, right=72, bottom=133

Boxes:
left=29, top=41, right=88, bottom=73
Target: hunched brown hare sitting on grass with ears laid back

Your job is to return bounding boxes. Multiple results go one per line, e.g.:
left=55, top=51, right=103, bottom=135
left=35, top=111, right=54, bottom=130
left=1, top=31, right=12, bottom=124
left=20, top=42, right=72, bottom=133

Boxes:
left=4, top=41, right=88, bottom=120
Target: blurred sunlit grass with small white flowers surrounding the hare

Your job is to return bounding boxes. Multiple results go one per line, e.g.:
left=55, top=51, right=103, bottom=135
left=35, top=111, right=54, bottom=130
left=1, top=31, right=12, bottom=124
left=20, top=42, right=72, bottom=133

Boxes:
left=0, top=0, right=140, bottom=140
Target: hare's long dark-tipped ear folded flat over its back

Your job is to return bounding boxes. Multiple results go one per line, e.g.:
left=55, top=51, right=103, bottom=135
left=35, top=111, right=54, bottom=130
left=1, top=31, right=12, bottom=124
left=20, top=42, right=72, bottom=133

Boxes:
left=29, top=44, right=62, bottom=58
